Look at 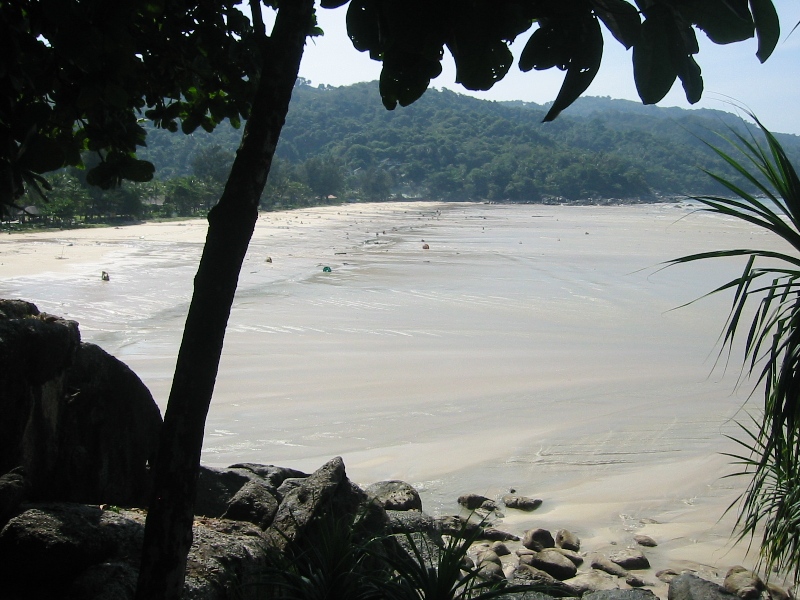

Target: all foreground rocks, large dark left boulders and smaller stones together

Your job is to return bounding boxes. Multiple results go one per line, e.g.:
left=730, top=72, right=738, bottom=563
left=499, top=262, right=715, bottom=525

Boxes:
left=0, top=300, right=789, bottom=600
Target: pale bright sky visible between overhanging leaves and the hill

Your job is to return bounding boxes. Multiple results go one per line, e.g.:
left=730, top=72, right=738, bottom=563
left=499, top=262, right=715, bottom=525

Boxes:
left=290, top=0, right=800, bottom=135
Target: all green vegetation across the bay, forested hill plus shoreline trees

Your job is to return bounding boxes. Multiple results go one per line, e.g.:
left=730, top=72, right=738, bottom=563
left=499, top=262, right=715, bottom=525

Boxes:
left=7, top=81, right=800, bottom=227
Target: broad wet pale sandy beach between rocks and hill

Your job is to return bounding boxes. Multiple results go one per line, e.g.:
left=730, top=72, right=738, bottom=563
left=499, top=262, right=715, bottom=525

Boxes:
left=0, top=203, right=792, bottom=592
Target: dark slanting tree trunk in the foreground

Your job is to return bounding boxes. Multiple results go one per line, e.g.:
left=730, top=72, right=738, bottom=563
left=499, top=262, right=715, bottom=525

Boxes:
left=136, top=0, right=314, bottom=600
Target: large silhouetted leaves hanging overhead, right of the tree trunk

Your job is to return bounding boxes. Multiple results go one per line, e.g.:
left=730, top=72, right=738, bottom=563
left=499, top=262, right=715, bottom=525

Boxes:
left=336, top=0, right=780, bottom=121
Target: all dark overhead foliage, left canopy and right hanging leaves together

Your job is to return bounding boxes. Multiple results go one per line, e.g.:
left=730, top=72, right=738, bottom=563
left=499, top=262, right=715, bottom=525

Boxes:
left=0, top=0, right=780, bottom=209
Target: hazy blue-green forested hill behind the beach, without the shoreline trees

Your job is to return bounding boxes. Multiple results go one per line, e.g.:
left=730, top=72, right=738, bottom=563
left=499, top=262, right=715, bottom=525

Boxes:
left=143, top=82, right=800, bottom=201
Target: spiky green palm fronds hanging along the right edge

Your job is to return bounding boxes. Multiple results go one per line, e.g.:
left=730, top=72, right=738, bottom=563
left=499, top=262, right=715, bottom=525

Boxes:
left=668, top=115, right=800, bottom=581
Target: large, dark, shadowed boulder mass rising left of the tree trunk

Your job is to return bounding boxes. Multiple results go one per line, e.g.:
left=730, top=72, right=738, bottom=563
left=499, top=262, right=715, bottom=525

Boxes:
left=0, top=300, right=161, bottom=506
